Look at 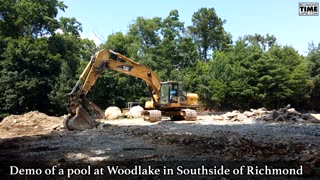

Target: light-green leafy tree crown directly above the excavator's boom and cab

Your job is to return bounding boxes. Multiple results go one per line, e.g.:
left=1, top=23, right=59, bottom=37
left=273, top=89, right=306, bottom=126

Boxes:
left=124, top=10, right=198, bottom=80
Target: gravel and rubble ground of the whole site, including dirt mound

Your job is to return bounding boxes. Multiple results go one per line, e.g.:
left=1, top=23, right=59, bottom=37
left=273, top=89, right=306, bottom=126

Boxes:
left=0, top=107, right=320, bottom=179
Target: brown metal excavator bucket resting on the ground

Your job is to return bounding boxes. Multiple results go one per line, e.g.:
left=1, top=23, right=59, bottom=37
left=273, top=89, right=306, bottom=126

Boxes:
left=64, top=105, right=99, bottom=130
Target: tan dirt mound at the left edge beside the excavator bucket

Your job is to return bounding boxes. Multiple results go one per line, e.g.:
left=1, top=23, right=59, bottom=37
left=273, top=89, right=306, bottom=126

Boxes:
left=0, top=111, right=63, bottom=138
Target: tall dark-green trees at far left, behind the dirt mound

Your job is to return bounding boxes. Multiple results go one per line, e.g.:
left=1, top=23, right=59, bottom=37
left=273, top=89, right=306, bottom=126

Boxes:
left=0, top=0, right=88, bottom=117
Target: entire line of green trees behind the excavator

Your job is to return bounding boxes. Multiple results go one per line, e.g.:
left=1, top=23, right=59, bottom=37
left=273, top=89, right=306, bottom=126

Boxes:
left=0, top=0, right=320, bottom=118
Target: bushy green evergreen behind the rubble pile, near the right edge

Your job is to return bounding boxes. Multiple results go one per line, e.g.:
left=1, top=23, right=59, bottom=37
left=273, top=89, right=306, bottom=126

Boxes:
left=267, top=46, right=310, bottom=108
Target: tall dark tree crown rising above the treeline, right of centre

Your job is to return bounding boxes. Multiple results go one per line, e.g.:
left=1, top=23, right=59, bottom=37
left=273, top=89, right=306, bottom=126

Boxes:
left=188, top=8, right=231, bottom=61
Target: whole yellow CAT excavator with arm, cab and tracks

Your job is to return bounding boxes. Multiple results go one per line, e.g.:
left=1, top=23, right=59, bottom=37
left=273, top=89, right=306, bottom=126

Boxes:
left=64, top=49, right=199, bottom=130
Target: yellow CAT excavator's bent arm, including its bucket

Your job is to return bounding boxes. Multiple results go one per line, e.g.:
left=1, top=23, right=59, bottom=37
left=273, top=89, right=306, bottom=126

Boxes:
left=64, top=49, right=160, bottom=130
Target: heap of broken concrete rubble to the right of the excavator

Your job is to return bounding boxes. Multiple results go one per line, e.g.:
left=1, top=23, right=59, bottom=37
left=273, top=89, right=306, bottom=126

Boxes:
left=213, top=104, right=320, bottom=123
